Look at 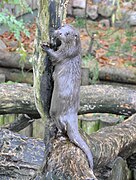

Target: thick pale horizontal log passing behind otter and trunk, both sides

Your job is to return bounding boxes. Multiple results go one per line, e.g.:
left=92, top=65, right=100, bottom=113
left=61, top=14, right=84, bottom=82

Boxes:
left=0, top=83, right=136, bottom=117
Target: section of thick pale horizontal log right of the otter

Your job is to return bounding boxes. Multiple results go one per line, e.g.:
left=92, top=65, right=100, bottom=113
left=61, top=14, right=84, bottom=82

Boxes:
left=79, top=85, right=136, bottom=116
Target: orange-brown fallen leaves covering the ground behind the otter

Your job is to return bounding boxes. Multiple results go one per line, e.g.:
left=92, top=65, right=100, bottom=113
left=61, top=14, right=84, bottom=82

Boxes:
left=0, top=18, right=136, bottom=67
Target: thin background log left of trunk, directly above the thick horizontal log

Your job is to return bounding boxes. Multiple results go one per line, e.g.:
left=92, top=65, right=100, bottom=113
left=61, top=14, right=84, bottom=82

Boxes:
left=0, top=67, right=33, bottom=84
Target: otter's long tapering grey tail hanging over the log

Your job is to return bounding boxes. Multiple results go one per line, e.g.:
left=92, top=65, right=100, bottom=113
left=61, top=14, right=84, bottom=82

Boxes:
left=67, top=122, right=93, bottom=170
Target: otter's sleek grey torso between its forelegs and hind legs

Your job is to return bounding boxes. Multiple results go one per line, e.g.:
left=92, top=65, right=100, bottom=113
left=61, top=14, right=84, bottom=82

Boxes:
left=50, top=59, right=81, bottom=117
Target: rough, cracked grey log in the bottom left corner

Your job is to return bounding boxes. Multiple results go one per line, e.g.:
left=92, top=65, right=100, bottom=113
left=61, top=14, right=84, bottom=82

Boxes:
left=0, top=129, right=45, bottom=180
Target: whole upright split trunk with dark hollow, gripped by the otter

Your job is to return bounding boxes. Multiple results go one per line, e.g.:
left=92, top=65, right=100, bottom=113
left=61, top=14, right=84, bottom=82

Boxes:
left=33, top=0, right=68, bottom=177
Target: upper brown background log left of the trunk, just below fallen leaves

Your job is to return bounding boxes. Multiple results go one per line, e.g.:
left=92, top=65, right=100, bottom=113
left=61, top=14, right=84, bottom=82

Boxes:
left=0, top=49, right=32, bottom=70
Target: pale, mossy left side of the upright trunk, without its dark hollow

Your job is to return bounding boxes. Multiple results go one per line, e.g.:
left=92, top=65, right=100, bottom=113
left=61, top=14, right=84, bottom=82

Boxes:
left=33, top=0, right=49, bottom=120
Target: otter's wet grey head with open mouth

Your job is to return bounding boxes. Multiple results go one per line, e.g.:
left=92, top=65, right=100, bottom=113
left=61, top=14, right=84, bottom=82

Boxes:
left=53, top=25, right=80, bottom=50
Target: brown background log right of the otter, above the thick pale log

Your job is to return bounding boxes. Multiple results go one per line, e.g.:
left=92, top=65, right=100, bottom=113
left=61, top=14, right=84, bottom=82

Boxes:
left=90, top=66, right=136, bottom=84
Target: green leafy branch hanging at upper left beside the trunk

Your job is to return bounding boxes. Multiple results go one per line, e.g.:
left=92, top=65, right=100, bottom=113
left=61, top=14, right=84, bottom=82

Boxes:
left=0, top=0, right=32, bottom=68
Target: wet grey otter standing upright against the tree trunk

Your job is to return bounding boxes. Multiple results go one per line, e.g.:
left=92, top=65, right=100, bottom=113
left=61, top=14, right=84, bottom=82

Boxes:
left=41, top=24, right=93, bottom=169
